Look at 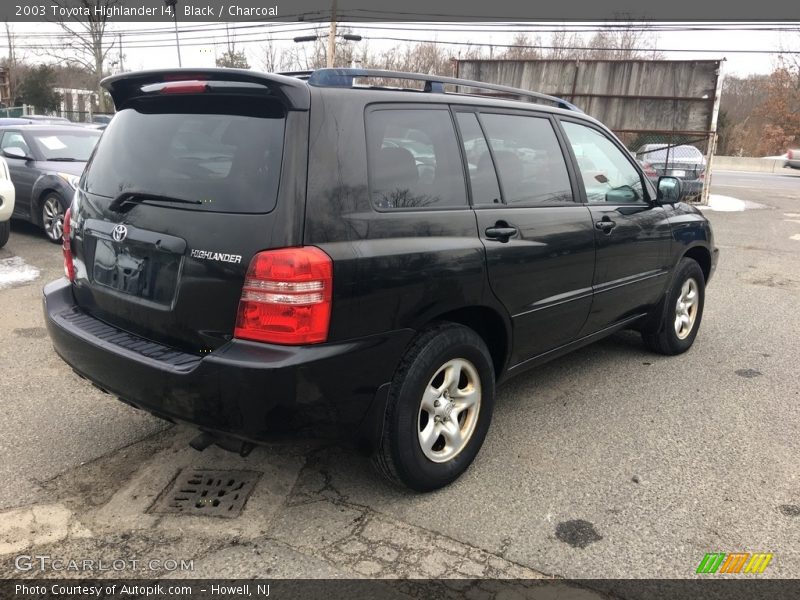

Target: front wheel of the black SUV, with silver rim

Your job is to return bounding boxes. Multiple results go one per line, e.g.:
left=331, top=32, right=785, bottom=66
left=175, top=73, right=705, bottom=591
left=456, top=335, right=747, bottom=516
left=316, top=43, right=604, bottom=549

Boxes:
left=642, top=258, right=705, bottom=355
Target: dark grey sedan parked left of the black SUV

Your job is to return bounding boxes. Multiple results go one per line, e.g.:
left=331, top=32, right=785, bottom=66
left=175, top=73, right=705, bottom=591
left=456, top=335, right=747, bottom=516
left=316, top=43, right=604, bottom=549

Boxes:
left=0, top=125, right=101, bottom=243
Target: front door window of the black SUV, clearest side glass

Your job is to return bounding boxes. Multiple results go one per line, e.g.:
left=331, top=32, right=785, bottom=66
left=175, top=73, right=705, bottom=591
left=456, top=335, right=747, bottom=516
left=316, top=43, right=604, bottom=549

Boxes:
left=562, top=121, right=646, bottom=204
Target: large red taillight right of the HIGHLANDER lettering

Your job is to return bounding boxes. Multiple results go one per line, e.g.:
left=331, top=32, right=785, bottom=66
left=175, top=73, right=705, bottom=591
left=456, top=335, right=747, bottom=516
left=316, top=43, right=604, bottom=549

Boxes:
left=234, top=246, right=333, bottom=345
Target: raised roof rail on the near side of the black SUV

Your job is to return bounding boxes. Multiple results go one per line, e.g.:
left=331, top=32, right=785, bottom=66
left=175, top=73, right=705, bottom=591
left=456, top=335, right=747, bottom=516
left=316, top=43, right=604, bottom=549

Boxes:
left=298, top=69, right=583, bottom=113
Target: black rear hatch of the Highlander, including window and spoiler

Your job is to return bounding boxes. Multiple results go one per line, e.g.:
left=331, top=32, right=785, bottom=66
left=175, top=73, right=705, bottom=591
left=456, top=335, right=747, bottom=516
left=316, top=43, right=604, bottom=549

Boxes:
left=71, top=69, right=309, bottom=353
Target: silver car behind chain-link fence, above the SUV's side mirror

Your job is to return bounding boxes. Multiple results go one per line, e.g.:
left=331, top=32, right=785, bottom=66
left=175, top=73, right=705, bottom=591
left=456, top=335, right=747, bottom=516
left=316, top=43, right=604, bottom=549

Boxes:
left=636, top=144, right=706, bottom=198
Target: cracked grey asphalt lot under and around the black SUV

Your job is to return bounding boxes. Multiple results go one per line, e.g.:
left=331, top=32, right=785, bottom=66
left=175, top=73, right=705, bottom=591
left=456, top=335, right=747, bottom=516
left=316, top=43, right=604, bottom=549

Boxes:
left=0, top=171, right=800, bottom=598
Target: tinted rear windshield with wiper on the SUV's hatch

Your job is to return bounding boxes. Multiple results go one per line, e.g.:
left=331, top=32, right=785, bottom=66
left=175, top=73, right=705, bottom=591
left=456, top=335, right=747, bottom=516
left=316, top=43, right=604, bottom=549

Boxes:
left=83, top=96, right=285, bottom=213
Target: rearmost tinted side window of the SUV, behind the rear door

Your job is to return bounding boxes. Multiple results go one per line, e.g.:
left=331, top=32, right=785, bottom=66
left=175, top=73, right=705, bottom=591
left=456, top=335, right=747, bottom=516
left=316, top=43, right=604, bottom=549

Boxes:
left=366, top=109, right=467, bottom=209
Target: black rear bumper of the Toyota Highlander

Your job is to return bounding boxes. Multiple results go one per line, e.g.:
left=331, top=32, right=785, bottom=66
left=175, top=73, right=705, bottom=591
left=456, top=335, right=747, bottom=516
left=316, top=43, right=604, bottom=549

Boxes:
left=44, top=279, right=414, bottom=444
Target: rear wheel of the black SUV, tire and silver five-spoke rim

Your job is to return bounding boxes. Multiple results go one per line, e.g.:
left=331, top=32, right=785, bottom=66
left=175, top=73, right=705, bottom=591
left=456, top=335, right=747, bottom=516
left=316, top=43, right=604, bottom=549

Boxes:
left=373, top=323, right=495, bottom=492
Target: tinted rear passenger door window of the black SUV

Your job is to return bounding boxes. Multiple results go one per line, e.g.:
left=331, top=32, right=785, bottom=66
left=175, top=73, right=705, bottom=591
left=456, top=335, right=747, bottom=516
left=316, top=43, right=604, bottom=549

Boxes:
left=481, top=114, right=573, bottom=206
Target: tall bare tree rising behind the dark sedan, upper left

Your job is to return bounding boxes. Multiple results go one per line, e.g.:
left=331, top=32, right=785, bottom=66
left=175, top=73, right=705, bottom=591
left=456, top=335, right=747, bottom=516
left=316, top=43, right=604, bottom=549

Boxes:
left=50, top=0, right=123, bottom=112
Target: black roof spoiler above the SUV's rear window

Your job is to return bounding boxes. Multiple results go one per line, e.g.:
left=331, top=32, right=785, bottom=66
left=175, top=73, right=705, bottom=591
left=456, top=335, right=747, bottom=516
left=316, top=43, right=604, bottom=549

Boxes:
left=100, top=68, right=311, bottom=110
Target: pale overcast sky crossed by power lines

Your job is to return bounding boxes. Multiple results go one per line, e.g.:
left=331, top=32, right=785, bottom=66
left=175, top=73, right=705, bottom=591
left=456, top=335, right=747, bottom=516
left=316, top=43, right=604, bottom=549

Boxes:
left=7, top=22, right=800, bottom=75
